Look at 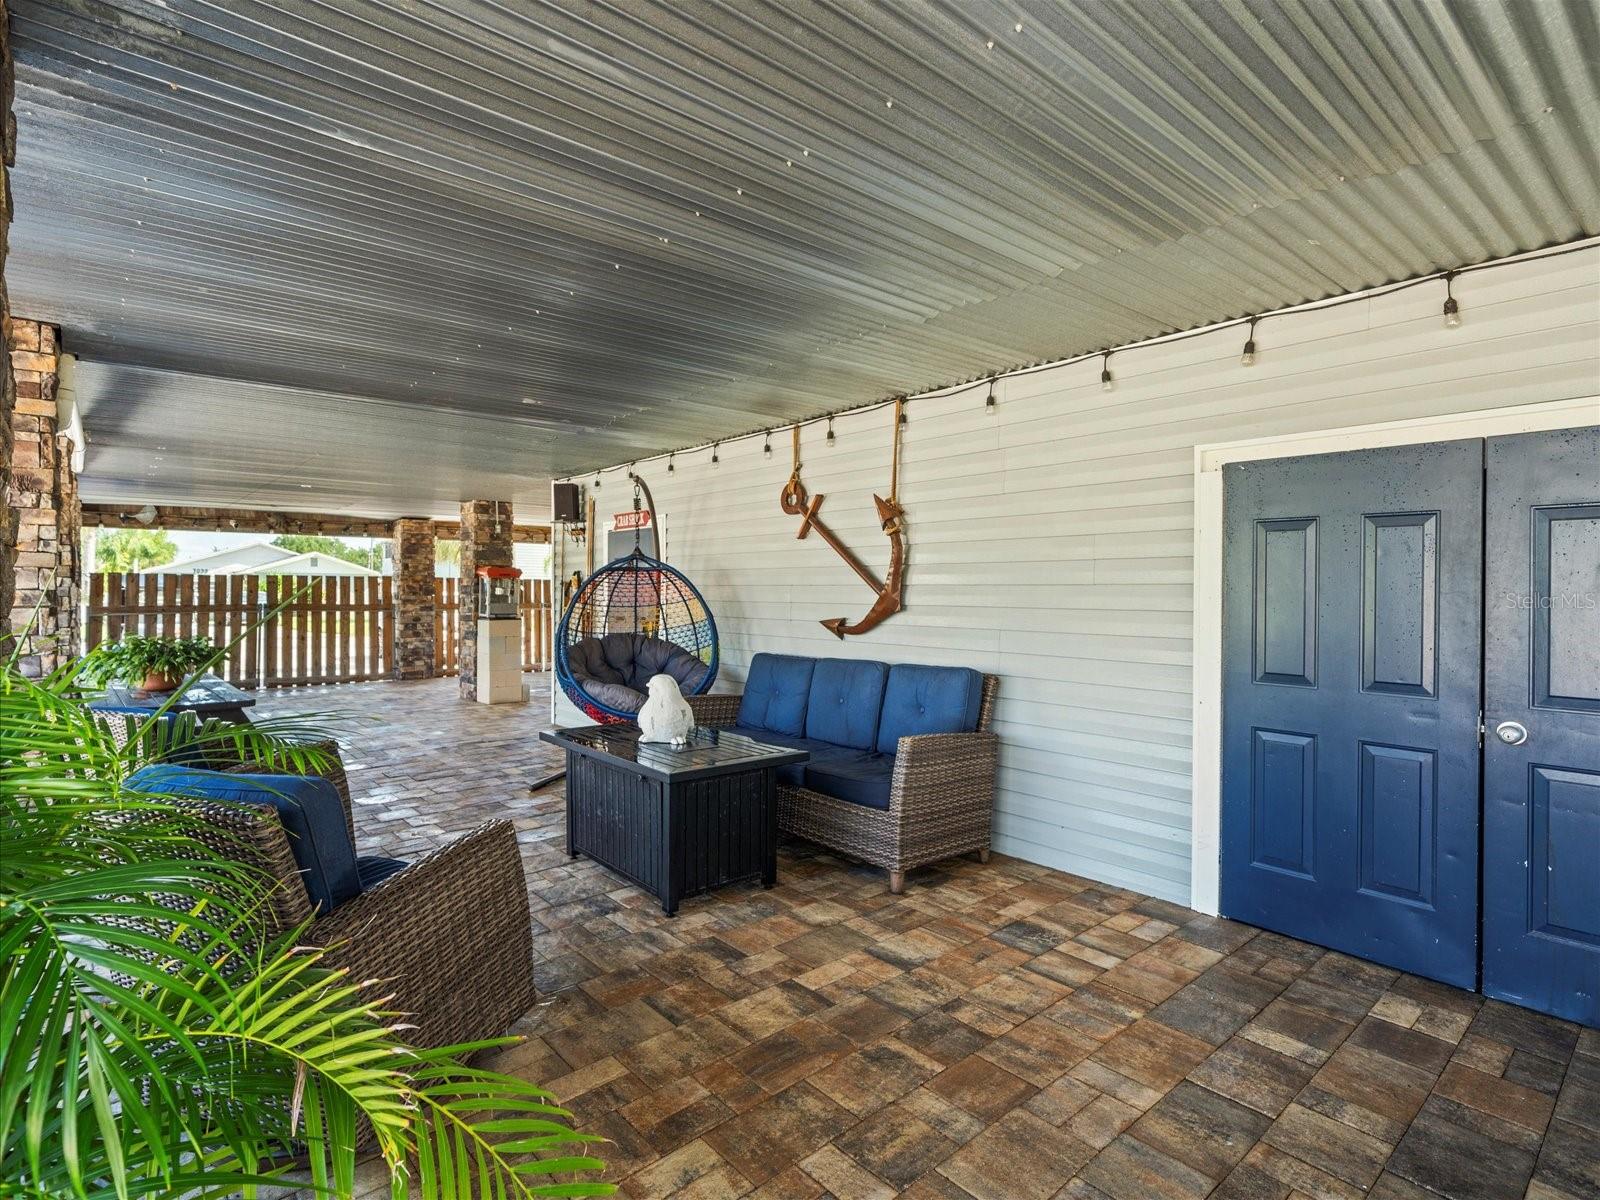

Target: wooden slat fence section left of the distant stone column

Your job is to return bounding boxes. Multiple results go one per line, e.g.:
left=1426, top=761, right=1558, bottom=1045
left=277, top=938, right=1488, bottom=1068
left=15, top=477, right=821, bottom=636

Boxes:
left=86, top=573, right=394, bottom=688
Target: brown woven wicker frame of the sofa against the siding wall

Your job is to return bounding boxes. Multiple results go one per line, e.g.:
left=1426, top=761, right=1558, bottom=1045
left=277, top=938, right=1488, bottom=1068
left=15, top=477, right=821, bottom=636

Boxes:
left=685, top=675, right=1000, bottom=896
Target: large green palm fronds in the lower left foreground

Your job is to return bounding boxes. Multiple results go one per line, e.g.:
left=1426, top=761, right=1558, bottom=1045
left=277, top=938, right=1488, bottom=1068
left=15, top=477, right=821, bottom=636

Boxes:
left=0, top=633, right=613, bottom=1200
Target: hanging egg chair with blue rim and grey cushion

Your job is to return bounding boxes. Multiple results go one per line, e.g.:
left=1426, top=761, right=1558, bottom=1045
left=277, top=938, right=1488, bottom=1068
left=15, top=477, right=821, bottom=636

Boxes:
left=555, top=476, right=717, bottom=725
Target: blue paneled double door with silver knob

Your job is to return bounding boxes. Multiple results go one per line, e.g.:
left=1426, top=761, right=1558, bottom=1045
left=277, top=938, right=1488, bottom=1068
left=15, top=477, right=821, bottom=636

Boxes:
left=1221, top=427, right=1600, bottom=1024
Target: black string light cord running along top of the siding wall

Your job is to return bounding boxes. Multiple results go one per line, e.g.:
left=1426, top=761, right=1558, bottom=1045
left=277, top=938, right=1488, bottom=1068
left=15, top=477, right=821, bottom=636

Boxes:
left=582, top=237, right=1600, bottom=478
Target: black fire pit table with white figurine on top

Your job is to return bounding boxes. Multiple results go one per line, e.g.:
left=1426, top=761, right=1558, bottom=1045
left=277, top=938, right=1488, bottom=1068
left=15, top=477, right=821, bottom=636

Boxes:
left=539, top=725, right=810, bottom=917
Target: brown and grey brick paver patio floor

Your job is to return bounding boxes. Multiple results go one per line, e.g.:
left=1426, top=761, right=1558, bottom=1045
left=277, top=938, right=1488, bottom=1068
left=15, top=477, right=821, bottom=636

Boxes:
left=261, top=680, right=1600, bottom=1200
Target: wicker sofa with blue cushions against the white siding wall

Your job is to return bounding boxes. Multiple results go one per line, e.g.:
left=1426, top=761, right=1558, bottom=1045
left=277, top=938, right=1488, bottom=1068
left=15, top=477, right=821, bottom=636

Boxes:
left=688, top=654, right=1000, bottom=894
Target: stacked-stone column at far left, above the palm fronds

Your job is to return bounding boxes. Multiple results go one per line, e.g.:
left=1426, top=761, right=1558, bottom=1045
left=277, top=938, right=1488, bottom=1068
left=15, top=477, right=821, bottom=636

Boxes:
left=6, top=320, right=82, bottom=675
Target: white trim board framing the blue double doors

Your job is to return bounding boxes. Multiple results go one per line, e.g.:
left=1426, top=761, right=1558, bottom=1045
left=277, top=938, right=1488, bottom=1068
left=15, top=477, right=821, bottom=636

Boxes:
left=1189, top=395, right=1600, bottom=915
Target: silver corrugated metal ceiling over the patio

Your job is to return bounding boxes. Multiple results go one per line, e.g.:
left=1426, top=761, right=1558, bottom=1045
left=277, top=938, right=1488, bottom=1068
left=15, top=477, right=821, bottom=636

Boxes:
left=11, top=0, right=1600, bottom=515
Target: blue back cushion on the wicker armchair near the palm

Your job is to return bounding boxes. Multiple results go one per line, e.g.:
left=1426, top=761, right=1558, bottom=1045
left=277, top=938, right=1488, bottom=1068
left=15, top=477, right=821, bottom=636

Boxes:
left=126, top=765, right=362, bottom=912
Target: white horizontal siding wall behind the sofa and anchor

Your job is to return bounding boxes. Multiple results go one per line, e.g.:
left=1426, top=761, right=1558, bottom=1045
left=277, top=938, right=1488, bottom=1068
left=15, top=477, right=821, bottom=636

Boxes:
left=558, top=250, right=1600, bottom=902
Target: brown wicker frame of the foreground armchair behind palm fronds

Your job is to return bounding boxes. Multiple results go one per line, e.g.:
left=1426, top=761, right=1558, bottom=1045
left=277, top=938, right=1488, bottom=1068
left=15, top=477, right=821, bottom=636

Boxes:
left=123, top=742, right=534, bottom=1046
